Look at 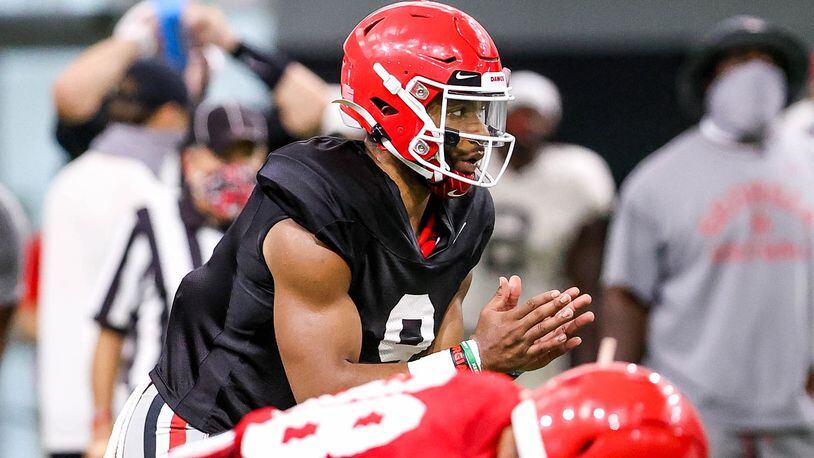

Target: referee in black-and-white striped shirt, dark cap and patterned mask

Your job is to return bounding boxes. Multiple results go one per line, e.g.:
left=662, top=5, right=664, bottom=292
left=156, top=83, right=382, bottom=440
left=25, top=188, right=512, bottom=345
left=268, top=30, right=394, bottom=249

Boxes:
left=86, top=104, right=267, bottom=457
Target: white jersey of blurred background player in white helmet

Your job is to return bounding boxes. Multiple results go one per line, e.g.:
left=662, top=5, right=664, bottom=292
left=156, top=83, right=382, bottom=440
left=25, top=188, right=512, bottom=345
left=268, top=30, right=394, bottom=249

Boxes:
left=463, top=144, right=615, bottom=330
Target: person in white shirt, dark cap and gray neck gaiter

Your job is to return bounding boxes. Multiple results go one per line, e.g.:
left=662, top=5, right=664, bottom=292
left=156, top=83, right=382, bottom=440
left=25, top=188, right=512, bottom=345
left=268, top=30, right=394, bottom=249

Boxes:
left=38, top=60, right=190, bottom=455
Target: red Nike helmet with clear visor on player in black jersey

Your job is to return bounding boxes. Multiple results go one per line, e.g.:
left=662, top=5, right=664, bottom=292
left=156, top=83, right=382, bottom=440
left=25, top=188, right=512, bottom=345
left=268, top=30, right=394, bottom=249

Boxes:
left=337, top=2, right=514, bottom=197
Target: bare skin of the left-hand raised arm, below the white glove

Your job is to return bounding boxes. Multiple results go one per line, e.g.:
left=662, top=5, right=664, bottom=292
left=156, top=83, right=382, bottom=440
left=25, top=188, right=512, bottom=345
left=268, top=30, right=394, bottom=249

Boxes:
left=53, top=38, right=140, bottom=123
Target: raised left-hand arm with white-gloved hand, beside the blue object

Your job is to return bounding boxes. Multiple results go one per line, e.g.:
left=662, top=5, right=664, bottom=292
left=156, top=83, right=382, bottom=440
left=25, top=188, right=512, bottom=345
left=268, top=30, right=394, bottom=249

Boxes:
left=53, top=2, right=157, bottom=124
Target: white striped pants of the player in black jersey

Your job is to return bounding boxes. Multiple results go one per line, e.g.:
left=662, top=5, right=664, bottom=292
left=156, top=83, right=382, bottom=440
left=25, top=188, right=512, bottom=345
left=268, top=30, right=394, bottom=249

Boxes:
left=105, top=382, right=208, bottom=458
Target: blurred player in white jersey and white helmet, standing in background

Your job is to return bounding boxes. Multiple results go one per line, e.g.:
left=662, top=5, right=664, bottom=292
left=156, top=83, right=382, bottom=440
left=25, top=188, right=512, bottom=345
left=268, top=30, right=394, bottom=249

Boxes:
left=464, top=71, right=615, bottom=386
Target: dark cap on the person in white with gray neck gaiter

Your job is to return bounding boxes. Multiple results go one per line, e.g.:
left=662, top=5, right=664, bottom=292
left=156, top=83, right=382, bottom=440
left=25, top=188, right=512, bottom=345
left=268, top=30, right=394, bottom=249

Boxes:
left=114, top=59, right=189, bottom=110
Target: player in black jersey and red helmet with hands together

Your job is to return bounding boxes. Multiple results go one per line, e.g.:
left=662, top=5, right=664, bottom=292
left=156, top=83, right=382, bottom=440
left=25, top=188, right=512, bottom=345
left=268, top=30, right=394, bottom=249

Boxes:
left=108, top=2, right=593, bottom=456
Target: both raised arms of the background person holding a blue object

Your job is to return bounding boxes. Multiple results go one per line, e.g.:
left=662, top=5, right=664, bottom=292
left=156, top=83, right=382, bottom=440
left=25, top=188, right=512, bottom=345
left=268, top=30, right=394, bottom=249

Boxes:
left=54, top=1, right=350, bottom=163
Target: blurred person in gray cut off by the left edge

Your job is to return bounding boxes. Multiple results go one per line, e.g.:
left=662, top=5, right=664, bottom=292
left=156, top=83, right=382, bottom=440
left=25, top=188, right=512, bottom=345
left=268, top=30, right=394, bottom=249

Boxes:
left=0, top=185, right=28, bottom=364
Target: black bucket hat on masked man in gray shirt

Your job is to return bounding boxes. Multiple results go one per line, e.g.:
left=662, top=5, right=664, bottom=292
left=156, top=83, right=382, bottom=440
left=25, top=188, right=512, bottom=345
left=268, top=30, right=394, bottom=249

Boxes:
left=678, top=16, right=808, bottom=118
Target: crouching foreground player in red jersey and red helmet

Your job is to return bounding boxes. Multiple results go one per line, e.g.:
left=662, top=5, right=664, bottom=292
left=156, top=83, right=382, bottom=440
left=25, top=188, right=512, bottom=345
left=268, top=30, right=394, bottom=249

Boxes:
left=170, top=363, right=707, bottom=458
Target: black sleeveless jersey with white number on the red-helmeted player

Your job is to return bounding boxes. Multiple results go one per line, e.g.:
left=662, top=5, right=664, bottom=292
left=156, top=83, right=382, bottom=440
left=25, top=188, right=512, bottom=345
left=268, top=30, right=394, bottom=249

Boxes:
left=150, top=137, right=494, bottom=433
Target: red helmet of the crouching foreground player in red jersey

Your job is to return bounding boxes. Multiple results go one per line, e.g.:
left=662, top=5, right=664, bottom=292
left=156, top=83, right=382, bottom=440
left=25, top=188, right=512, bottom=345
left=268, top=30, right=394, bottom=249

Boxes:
left=512, top=363, right=708, bottom=458
